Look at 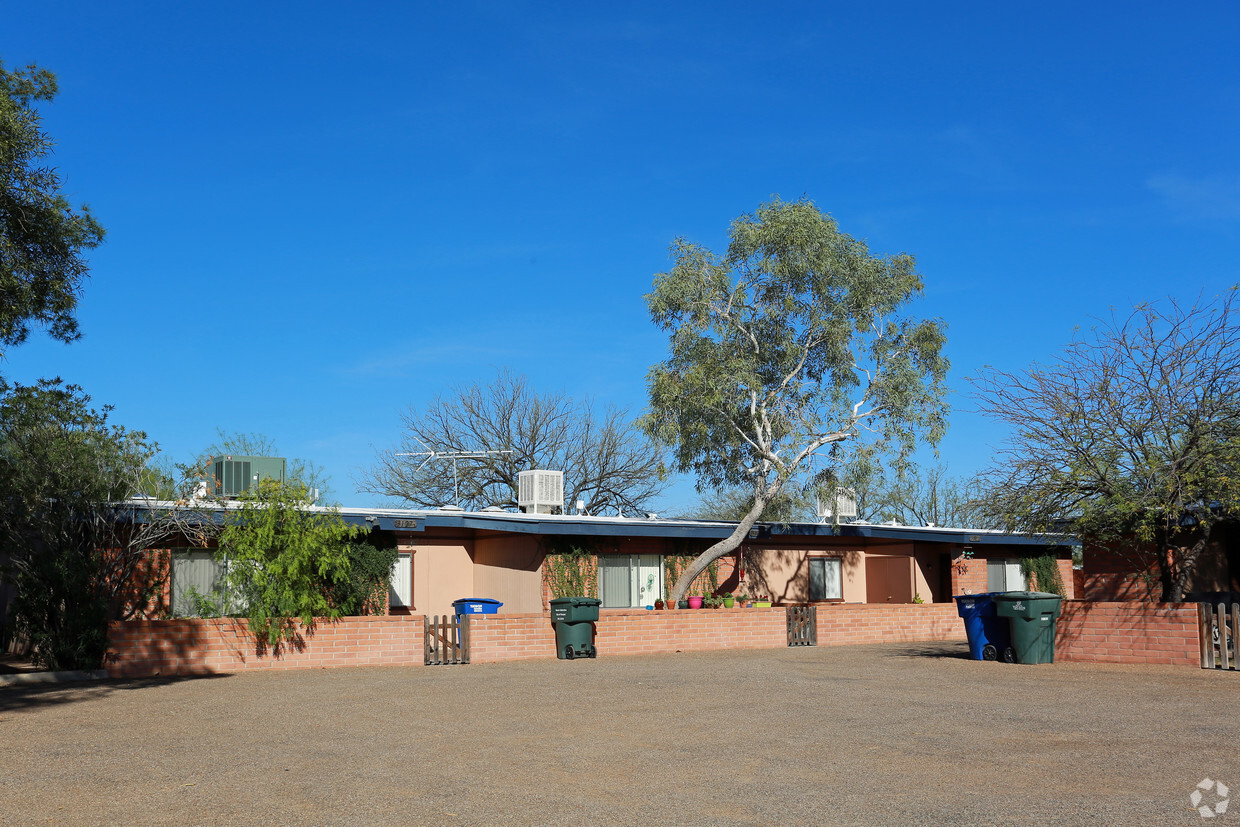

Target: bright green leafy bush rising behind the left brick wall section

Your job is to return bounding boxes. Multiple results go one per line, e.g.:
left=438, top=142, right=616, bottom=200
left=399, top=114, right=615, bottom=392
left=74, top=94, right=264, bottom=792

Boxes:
left=216, top=480, right=361, bottom=647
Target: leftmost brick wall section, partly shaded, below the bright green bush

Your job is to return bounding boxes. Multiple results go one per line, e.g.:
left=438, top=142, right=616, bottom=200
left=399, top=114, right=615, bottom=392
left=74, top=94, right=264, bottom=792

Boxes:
left=104, top=615, right=423, bottom=677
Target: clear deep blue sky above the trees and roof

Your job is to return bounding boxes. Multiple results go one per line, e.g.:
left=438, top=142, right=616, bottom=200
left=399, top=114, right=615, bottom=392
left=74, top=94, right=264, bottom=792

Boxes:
left=0, top=0, right=1240, bottom=511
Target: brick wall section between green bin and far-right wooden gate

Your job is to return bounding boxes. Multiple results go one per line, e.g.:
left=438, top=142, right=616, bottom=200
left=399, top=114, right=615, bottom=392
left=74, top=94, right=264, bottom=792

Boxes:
left=1055, top=600, right=1202, bottom=666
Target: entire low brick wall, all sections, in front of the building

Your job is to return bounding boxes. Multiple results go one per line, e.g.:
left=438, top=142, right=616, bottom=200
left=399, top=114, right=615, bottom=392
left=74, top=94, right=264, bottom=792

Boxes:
left=105, top=601, right=1199, bottom=677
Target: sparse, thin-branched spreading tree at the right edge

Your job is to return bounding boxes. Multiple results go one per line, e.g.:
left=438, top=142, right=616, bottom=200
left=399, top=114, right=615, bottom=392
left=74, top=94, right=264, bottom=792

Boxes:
left=973, top=288, right=1240, bottom=603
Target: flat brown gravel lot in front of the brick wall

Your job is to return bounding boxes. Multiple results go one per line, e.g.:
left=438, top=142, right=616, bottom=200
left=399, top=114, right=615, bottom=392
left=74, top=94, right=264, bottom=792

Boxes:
left=0, top=643, right=1240, bottom=825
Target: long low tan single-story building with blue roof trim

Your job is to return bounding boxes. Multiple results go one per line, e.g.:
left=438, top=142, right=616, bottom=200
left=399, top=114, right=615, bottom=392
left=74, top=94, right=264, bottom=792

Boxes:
left=142, top=500, right=1073, bottom=615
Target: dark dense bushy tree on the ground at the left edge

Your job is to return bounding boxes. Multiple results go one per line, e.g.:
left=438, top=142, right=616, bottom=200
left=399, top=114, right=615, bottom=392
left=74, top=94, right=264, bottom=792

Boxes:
left=0, top=379, right=159, bottom=670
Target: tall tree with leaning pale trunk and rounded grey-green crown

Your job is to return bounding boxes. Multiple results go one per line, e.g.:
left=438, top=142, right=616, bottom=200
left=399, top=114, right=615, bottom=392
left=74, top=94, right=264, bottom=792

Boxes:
left=645, top=198, right=947, bottom=600
